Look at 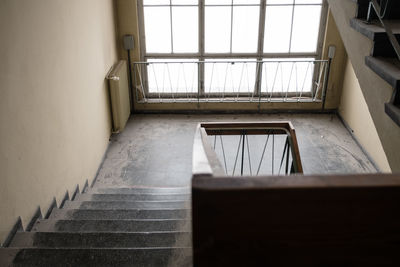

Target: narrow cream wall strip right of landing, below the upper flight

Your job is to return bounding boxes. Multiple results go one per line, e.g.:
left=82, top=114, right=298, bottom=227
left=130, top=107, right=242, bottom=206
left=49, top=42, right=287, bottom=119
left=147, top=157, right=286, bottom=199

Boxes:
left=339, top=60, right=391, bottom=172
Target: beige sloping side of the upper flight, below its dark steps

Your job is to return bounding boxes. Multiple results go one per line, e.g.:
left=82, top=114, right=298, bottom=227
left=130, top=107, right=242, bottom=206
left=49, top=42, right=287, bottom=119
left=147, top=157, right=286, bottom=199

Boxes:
left=328, top=0, right=400, bottom=172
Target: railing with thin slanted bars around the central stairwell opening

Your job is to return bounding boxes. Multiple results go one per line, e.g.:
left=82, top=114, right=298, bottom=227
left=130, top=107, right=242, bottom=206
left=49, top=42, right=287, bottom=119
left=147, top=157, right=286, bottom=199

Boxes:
left=193, top=122, right=303, bottom=176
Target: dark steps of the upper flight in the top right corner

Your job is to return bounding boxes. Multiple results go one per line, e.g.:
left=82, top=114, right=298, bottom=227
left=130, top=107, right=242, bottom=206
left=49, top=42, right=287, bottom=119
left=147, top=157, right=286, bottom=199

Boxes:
left=350, top=0, right=400, bottom=126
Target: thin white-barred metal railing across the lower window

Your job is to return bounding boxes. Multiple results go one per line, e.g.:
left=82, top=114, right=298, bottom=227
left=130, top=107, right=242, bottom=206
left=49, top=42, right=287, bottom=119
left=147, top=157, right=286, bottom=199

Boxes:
left=133, top=59, right=330, bottom=103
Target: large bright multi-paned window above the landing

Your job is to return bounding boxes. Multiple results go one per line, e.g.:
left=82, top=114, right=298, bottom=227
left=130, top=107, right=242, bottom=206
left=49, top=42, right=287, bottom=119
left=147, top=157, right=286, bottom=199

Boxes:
left=138, top=0, right=326, bottom=98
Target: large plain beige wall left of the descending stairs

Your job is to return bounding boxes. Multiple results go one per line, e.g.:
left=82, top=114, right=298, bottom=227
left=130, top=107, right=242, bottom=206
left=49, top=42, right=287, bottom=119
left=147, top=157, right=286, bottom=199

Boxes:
left=0, top=0, right=117, bottom=242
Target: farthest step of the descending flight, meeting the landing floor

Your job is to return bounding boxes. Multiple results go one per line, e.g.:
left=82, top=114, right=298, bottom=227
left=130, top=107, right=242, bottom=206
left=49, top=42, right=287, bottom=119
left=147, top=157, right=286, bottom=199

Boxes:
left=87, top=187, right=191, bottom=194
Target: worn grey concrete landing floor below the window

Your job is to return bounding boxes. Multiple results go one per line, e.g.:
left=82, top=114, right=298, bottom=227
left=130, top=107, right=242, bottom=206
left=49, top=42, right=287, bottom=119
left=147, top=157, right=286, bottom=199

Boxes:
left=94, top=114, right=376, bottom=187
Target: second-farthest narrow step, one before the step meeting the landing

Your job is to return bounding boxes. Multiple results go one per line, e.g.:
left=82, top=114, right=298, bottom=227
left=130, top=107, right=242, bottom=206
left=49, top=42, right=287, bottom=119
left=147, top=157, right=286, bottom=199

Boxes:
left=74, top=194, right=191, bottom=201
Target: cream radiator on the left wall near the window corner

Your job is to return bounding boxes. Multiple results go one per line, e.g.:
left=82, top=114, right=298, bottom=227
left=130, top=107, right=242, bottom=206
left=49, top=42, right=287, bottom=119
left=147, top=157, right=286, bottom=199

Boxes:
left=107, top=60, right=131, bottom=132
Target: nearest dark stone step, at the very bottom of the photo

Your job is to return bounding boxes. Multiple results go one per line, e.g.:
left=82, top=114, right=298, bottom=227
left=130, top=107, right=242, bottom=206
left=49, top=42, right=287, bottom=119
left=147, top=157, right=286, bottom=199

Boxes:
left=0, top=248, right=193, bottom=267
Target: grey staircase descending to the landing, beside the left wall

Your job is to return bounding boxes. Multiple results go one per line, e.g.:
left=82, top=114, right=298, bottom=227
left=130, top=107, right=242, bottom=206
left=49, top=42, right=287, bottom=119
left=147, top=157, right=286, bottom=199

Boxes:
left=0, top=188, right=192, bottom=266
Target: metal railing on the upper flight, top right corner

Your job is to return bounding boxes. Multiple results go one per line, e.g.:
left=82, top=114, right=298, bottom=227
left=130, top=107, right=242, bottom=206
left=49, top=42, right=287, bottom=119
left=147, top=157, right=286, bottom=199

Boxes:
left=367, top=0, right=400, bottom=60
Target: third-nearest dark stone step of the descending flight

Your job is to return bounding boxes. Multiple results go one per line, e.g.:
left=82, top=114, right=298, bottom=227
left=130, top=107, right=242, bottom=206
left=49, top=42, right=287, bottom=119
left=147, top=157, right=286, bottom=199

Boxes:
left=32, top=219, right=192, bottom=232
